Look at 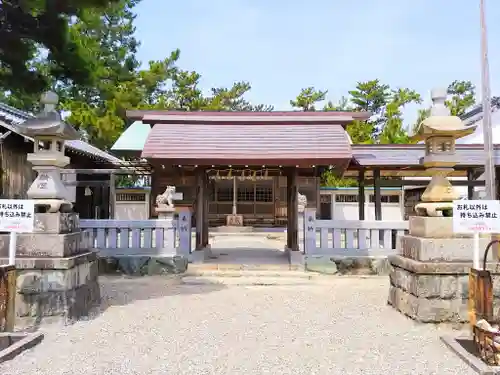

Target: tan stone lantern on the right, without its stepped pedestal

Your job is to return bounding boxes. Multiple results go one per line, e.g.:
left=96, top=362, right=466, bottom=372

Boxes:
left=413, top=89, right=475, bottom=216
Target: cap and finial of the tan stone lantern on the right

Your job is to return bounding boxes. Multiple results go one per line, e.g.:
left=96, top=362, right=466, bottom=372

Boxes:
left=412, top=89, right=476, bottom=141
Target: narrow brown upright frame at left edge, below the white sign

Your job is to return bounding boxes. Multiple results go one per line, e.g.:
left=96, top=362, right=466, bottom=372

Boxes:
left=0, top=265, right=16, bottom=332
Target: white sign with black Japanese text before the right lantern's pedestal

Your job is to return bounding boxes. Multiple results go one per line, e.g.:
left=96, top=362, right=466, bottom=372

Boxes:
left=453, top=200, right=500, bottom=234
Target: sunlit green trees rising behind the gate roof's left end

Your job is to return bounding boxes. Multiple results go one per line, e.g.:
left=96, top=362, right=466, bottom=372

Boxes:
left=0, top=0, right=273, bottom=149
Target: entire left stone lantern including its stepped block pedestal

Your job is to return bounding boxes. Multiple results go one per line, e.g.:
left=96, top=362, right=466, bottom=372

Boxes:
left=0, top=92, right=100, bottom=327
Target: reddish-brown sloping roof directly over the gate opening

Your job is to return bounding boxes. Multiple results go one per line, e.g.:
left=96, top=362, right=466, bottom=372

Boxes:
left=142, top=122, right=352, bottom=166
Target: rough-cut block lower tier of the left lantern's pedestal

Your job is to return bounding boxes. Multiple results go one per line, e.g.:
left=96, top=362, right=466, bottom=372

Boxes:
left=2, top=252, right=100, bottom=328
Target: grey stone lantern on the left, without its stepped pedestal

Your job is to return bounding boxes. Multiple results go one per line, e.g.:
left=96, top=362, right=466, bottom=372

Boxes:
left=17, top=92, right=80, bottom=212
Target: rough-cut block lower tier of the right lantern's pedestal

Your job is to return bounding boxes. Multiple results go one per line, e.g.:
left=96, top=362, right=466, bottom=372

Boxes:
left=388, top=255, right=500, bottom=323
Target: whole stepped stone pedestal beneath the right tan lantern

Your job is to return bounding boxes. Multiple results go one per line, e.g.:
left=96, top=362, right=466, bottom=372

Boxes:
left=388, top=216, right=492, bottom=323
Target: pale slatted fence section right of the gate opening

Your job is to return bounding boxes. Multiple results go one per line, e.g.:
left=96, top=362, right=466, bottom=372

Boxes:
left=303, top=209, right=408, bottom=255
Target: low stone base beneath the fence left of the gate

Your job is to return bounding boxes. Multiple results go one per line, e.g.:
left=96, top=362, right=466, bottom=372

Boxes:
left=99, top=256, right=188, bottom=276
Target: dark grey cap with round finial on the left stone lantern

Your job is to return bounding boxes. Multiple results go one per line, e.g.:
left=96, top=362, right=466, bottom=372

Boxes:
left=16, top=92, right=80, bottom=140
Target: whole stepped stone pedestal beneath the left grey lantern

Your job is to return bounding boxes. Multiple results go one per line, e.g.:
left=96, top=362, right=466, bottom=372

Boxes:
left=0, top=213, right=100, bottom=327
